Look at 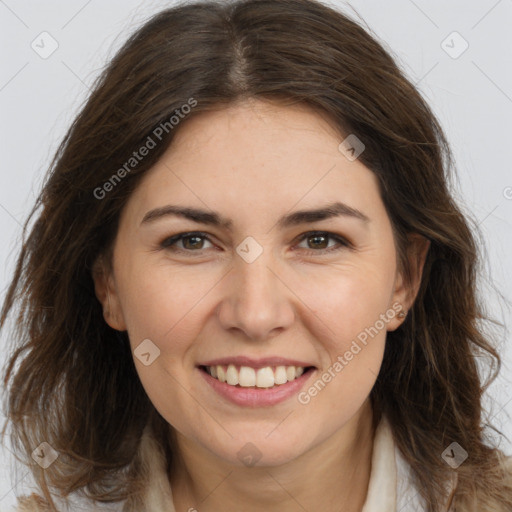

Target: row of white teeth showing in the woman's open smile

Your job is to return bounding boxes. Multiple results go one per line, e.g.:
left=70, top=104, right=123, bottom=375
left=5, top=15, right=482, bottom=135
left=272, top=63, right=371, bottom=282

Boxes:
left=199, top=364, right=315, bottom=389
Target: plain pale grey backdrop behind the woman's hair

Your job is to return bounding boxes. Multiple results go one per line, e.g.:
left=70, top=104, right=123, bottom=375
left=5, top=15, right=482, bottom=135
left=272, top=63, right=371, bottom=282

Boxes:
left=0, top=0, right=512, bottom=510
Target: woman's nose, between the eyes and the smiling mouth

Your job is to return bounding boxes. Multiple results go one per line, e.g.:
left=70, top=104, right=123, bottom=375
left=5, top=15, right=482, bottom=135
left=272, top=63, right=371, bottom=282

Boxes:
left=217, top=251, right=295, bottom=341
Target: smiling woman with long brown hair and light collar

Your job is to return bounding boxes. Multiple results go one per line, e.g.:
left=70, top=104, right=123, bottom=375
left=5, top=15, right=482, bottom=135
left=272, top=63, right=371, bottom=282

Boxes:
left=2, top=0, right=512, bottom=512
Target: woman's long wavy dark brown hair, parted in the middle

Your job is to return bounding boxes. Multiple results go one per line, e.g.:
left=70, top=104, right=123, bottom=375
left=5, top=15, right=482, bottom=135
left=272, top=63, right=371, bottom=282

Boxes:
left=0, top=0, right=512, bottom=512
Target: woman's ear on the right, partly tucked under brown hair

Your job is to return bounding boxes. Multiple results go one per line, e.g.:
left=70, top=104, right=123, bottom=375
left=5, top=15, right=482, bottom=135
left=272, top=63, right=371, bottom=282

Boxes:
left=387, top=233, right=430, bottom=331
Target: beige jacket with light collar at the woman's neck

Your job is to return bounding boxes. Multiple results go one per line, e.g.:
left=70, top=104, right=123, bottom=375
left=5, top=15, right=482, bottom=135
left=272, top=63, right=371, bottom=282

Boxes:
left=6, top=418, right=512, bottom=512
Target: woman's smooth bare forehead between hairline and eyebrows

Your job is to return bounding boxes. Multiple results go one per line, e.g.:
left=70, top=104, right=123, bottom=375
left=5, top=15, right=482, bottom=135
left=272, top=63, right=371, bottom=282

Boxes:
left=126, top=100, right=382, bottom=228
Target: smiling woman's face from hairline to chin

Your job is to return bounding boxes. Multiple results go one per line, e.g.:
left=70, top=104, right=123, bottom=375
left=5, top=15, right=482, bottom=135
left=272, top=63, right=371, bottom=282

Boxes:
left=96, top=101, right=422, bottom=465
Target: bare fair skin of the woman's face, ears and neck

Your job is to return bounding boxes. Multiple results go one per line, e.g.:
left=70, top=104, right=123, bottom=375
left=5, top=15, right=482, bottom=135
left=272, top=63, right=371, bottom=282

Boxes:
left=94, top=100, right=428, bottom=512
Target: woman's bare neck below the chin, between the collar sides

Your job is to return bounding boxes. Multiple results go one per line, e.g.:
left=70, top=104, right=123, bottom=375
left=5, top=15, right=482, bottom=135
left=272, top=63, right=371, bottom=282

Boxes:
left=170, top=401, right=374, bottom=512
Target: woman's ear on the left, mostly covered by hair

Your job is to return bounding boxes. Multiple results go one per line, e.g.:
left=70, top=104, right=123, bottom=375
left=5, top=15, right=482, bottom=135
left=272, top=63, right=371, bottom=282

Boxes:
left=92, top=255, right=126, bottom=331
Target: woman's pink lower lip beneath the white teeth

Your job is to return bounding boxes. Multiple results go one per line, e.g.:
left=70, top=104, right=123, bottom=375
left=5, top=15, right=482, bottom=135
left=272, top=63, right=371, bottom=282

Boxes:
left=197, top=368, right=315, bottom=407
